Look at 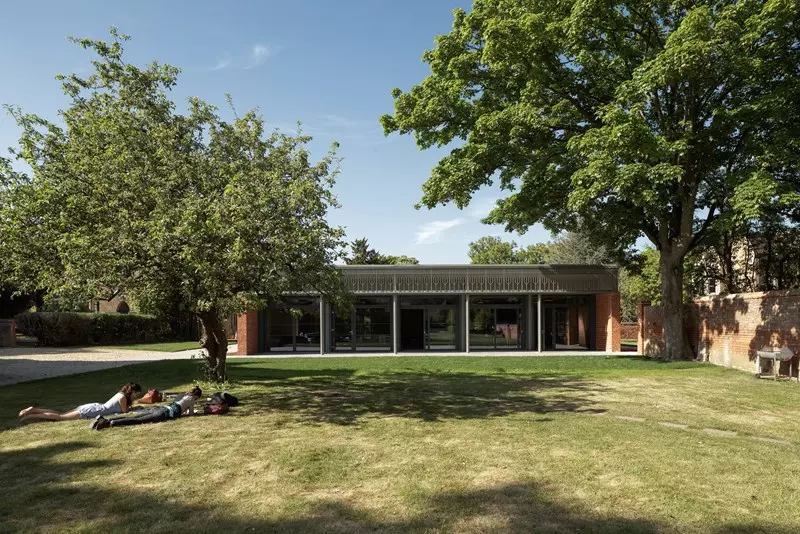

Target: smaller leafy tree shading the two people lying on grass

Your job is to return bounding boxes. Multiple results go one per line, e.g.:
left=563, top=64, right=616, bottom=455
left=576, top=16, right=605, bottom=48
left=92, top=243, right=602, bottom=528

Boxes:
left=0, top=30, right=343, bottom=380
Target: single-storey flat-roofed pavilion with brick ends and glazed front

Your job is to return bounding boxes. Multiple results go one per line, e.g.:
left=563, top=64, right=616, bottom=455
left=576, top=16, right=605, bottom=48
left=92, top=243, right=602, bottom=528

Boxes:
left=237, top=265, right=620, bottom=355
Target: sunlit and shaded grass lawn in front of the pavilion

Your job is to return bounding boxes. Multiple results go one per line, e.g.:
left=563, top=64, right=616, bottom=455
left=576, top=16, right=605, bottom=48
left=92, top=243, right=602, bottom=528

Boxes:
left=0, top=357, right=800, bottom=534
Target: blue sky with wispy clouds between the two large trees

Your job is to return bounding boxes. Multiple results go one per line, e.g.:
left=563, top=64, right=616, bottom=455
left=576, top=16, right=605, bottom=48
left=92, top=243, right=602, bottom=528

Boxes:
left=0, top=0, right=550, bottom=263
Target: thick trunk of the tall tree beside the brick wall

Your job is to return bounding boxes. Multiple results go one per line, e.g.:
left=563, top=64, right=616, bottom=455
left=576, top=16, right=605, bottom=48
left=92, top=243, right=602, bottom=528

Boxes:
left=659, top=250, right=694, bottom=360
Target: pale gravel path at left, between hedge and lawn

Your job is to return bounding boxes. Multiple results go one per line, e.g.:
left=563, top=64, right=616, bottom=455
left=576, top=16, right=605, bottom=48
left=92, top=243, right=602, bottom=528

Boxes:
left=0, top=347, right=209, bottom=386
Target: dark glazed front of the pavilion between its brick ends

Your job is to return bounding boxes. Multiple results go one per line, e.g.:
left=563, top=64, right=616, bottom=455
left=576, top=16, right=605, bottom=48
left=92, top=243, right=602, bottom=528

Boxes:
left=259, top=295, right=595, bottom=353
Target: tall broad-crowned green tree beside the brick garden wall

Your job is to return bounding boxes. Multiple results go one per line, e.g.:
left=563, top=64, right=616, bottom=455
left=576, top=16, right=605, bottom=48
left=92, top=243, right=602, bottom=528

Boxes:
left=381, top=0, right=800, bottom=359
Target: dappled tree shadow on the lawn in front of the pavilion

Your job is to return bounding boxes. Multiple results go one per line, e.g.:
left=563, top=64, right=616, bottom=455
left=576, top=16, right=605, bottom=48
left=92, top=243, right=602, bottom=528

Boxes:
left=231, top=369, right=605, bottom=425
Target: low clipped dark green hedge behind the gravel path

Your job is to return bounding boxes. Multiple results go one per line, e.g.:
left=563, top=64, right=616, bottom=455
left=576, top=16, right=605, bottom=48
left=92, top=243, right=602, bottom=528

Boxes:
left=16, top=312, right=173, bottom=347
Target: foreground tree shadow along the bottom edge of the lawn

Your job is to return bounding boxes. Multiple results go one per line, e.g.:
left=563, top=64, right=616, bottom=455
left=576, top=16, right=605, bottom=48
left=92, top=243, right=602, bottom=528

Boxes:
left=0, top=442, right=796, bottom=534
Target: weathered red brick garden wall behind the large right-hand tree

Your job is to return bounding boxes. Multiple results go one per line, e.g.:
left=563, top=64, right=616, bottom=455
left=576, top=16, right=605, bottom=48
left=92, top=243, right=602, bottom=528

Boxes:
left=639, top=291, right=800, bottom=372
